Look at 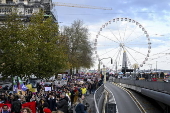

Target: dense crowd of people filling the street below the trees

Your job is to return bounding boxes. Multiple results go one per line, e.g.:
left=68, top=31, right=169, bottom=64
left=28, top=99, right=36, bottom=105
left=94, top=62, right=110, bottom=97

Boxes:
left=0, top=75, right=102, bottom=113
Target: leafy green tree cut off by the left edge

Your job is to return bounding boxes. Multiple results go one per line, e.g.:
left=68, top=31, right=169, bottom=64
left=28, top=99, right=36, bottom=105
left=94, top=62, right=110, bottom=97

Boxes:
left=0, top=13, right=25, bottom=76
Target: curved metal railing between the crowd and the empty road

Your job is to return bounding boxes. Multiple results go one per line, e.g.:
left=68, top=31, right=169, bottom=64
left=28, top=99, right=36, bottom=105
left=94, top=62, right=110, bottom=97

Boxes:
left=94, top=84, right=104, bottom=113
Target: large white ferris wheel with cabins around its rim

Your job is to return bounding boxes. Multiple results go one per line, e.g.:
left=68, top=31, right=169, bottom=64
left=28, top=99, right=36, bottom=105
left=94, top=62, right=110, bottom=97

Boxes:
left=94, top=18, right=151, bottom=68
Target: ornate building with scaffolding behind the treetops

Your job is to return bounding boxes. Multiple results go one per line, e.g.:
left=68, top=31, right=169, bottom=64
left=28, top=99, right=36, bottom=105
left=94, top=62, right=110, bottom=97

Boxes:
left=0, top=0, right=56, bottom=21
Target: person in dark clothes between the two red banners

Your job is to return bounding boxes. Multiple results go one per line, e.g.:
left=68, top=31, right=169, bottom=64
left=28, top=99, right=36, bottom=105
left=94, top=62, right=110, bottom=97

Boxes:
left=11, top=95, right=21, bottom=113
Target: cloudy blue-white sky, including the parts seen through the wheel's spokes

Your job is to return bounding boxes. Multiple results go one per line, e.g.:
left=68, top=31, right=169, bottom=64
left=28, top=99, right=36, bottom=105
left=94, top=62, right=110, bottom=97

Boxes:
left=53, top=0, right=170, bottom=70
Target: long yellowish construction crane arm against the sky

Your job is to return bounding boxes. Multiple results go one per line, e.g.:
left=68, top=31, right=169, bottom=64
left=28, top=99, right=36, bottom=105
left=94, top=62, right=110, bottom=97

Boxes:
left=53, top=2, right=112, bottom=10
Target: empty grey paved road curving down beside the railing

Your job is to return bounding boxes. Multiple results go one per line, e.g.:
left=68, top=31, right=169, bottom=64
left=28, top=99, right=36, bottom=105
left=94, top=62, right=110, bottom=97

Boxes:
left=106, top=82, right=141, bottom=113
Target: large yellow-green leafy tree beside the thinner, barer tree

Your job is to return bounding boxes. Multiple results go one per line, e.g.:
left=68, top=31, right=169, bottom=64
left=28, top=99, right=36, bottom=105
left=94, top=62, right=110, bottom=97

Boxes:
left=28, top=14, right=68, bottom=77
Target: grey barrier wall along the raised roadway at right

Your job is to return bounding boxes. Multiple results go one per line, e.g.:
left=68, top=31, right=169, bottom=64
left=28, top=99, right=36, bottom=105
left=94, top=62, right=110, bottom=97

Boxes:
left=114, top=79, right=170, bottom=94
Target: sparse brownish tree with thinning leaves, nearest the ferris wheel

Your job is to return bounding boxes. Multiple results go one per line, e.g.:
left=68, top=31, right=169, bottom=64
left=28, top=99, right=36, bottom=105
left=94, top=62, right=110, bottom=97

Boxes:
left=62, top=20, right=93, bottom=74
